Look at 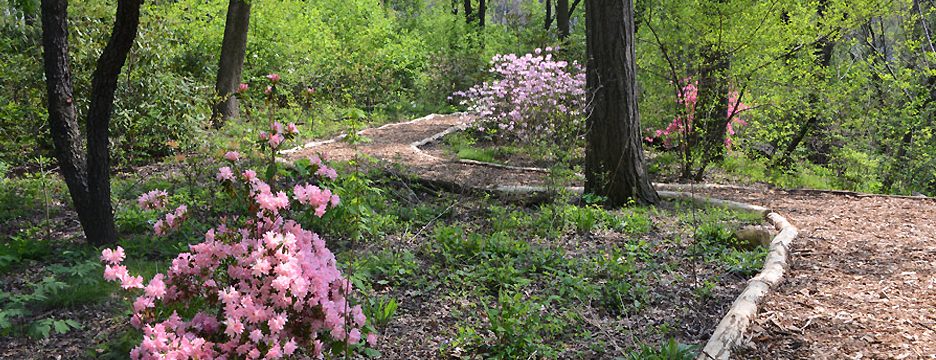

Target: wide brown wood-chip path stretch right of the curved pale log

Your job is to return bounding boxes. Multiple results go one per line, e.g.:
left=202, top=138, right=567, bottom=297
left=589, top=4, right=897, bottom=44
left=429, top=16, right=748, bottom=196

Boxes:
left=692, top=190, right=936, bottom=359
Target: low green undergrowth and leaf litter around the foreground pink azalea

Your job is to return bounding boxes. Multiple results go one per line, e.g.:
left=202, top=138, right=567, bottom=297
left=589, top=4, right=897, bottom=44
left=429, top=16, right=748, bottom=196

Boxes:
left=0, top=151, right=765, bottom=359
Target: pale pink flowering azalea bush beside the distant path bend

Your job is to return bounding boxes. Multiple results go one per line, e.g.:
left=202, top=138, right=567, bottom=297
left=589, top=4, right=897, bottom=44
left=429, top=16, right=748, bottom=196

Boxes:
left=452, top=48, right=586, bottom=143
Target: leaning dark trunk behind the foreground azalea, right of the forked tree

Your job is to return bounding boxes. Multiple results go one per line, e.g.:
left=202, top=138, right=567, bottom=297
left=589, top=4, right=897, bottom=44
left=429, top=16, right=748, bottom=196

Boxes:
left=211, top=0, right=250, bottom=128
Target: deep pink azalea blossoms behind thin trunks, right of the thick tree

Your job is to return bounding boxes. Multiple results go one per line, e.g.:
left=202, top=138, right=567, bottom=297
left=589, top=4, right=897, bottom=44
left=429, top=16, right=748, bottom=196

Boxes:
left=644, top=79, right=750, bottom=149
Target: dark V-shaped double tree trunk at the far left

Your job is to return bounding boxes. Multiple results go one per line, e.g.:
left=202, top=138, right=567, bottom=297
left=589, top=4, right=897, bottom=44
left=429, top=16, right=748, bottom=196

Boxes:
left=42, top=0, right=142, bottom=245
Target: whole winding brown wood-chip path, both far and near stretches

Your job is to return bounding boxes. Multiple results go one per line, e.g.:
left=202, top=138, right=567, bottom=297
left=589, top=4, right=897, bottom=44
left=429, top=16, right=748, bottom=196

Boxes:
left=287, top=115, right=936, bottom=359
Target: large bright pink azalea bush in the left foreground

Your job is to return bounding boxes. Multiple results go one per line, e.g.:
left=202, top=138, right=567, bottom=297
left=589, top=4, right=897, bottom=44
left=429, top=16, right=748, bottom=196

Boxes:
left=101, top=119, right=376, bottom=359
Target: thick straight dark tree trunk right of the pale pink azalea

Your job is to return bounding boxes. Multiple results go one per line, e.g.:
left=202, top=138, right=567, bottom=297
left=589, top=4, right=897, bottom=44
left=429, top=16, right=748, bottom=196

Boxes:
left=585, top=0, right=660, bottom=206
